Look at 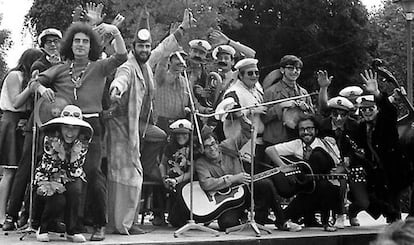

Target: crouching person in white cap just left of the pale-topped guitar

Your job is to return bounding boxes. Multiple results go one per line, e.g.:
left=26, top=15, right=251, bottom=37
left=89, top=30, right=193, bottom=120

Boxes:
left=153, top=119, right=192, bottom=227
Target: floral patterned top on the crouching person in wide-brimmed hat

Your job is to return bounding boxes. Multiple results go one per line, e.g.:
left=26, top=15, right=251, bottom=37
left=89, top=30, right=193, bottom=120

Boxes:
left=34, top=136, right=88, bottom=196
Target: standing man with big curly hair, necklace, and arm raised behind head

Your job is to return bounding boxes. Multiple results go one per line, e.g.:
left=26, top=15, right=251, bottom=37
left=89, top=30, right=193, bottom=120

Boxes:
left=32, top=22, right=127, bottom=241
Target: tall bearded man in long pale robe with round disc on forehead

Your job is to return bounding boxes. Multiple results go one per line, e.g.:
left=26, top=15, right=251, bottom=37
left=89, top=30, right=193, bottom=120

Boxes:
left=108, top=9, right=195, bottom=234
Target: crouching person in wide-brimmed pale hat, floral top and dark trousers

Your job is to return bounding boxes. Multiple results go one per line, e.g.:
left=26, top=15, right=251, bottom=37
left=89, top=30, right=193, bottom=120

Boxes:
left=35, top=105, right=93, bottom=242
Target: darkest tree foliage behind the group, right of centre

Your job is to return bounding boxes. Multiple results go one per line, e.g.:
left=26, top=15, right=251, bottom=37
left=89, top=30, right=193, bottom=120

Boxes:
left=224, top=0, right=375, bottom=93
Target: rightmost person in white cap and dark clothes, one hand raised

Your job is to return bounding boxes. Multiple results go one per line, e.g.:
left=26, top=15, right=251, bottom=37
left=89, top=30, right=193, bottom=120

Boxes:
left=355, top=71, right=412, bottom=223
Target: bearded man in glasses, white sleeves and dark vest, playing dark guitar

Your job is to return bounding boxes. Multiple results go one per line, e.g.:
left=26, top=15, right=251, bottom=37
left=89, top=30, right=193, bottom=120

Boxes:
left=265, top=114, right=341, bottom=231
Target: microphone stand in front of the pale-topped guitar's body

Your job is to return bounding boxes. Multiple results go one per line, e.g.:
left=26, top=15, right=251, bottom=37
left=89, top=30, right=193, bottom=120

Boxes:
left=174, top=58, right=219, bottom=237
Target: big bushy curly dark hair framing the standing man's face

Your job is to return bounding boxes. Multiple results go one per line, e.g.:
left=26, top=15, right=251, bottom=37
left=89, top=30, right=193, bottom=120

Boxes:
left=60, top=22, right=102, bottom=61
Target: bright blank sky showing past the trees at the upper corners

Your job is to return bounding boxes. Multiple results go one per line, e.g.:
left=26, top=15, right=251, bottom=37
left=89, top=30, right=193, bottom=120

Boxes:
left=0, top=0, right=381, bottom=67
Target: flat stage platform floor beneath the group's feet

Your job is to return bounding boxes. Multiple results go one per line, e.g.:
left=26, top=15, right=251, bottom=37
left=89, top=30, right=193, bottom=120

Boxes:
left=0, top=213, right=386, bottom=245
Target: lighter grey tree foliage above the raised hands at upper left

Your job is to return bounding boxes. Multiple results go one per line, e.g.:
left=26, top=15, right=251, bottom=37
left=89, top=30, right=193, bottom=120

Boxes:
left=25, top=0, right=240, bottom=48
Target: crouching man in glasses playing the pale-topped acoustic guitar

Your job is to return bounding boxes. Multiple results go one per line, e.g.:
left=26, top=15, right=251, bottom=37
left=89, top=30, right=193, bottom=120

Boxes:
left=195, top=116, right=302, bottom=231
